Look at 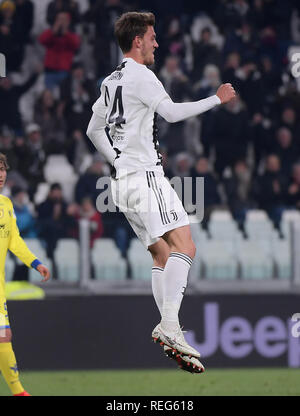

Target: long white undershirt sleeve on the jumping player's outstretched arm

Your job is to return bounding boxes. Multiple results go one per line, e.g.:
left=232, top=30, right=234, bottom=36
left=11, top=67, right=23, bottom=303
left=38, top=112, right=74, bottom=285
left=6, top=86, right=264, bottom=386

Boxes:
left=156, top=95, right=221, bottom=123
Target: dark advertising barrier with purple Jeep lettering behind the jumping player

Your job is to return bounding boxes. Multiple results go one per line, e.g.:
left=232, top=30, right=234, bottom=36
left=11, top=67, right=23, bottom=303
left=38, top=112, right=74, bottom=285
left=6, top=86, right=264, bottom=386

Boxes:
left=8, top=295, right=300, bottom=370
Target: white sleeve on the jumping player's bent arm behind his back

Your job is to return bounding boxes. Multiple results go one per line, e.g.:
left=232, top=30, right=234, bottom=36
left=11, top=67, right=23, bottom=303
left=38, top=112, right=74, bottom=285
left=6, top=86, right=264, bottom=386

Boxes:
left=86, top=84, right=117, bottom=166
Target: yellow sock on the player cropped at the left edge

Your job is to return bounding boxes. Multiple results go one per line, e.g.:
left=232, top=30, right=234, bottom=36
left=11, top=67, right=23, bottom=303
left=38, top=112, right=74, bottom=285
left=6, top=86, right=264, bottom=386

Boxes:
left=0, top=342, right=24, bottom=394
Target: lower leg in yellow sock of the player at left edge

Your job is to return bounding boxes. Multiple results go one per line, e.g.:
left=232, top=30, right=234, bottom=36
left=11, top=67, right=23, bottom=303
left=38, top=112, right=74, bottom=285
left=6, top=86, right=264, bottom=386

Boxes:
left=0, top=328, right=30, bottom=396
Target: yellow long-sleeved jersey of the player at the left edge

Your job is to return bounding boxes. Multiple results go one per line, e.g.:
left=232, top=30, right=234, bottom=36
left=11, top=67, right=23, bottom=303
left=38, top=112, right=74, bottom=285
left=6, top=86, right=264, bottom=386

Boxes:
left=0, top=195, right=37, bottom=297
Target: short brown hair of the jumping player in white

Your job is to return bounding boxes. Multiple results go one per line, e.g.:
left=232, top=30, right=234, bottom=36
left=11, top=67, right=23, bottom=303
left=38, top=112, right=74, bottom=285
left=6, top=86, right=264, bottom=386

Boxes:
left=115, top=12, right=155, bottom=53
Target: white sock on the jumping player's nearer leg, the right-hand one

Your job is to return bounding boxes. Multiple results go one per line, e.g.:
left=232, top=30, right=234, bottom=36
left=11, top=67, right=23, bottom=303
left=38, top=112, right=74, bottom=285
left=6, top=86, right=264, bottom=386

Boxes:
left=161, top=252, right=193, bottom=333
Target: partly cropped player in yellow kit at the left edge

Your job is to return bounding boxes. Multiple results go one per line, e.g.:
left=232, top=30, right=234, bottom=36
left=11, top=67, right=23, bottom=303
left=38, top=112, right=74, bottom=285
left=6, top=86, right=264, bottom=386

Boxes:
left=0, top=153, right=50, bottom=396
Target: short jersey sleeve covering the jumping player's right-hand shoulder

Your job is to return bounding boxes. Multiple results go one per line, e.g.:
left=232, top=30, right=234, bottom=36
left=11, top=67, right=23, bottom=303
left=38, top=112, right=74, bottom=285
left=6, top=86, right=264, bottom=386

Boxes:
left=136, top=68, right=170, bottom=111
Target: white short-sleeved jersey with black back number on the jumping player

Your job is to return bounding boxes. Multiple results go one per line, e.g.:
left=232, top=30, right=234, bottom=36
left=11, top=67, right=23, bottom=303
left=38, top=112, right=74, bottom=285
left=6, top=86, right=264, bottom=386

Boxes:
left=93, top=58, right=170, bottom=178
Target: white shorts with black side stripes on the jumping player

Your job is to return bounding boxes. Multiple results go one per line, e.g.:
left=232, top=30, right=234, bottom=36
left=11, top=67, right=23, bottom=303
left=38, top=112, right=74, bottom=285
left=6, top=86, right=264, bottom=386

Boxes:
left=111, top=171, right=189, bottom=248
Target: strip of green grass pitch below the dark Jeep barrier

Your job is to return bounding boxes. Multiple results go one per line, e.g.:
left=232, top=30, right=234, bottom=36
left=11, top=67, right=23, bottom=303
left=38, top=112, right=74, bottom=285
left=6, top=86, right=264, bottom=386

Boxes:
left=0, top=368, right=300, bottom=396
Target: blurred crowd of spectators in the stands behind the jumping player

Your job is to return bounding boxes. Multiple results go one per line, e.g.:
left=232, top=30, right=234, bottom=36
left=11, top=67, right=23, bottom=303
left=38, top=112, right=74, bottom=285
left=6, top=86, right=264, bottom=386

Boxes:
left=0, top=0, right=300, bottom=268
